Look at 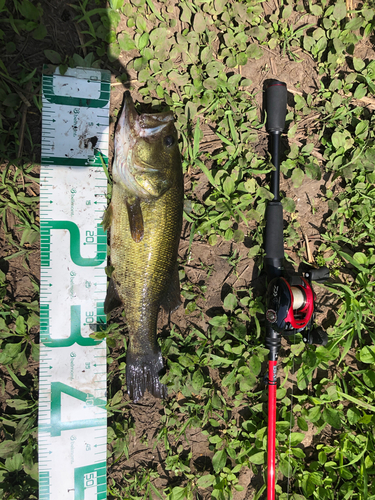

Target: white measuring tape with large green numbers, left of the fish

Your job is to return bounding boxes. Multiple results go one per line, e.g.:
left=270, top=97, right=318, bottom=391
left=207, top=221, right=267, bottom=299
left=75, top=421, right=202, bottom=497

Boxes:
left=38, top=68, right=110, bottom=500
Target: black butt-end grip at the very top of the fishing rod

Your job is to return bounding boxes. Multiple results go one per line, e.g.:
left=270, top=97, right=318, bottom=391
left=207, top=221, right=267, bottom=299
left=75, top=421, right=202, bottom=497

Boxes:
left=266, top=80, right=287, bottom=132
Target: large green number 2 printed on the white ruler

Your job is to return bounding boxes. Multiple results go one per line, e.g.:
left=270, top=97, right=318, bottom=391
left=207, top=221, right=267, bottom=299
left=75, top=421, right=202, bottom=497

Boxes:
left=40, top=220, right=107, bottom=267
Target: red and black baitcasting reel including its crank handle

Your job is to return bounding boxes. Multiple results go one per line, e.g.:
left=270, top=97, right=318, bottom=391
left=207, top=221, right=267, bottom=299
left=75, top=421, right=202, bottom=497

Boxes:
left=266, top=267, right=329, bottom=345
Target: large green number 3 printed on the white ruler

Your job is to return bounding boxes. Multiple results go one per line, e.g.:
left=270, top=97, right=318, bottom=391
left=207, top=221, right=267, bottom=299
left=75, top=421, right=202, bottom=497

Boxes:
left=40, top=303, right=103, bottom=347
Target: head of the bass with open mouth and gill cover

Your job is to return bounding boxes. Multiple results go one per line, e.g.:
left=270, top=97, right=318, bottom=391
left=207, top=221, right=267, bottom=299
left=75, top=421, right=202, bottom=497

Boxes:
left=113, top=94, right=182, bottom=200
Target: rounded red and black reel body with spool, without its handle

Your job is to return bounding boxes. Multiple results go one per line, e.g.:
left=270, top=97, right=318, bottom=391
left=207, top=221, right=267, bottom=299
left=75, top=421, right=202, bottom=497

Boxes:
left=266, top=276, right=316, bottom=334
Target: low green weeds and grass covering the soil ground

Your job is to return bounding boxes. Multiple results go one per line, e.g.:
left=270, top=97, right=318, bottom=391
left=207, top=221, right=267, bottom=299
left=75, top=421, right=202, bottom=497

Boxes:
left=0, top=0, right=375, bottom=500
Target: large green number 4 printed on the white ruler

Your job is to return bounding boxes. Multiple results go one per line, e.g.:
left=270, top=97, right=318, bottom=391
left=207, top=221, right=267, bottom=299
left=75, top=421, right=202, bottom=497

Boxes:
left=50, top=382, right=107, bottom=436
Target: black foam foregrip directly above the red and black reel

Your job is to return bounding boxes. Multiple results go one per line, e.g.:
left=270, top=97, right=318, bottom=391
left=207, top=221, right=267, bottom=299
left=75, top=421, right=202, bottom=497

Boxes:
left=264, top=201, right=284, bottom=260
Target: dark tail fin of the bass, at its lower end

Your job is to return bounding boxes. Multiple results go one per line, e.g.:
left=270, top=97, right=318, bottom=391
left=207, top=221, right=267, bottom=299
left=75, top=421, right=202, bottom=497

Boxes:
left=126, top=348, right=168, bottom=403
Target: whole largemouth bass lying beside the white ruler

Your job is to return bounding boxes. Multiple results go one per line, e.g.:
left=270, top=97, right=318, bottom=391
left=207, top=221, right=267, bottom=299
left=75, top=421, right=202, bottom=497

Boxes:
left=103, top=93, right=184, bottom=401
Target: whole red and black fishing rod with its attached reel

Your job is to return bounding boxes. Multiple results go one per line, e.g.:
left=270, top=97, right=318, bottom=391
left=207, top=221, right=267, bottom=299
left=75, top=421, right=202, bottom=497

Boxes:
left=264, top=80, right=329, bottom=500
